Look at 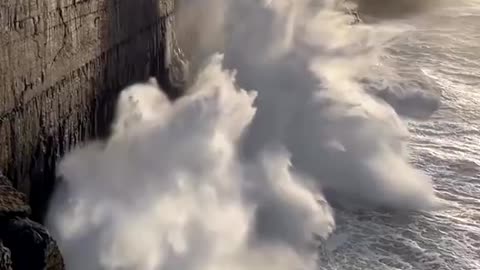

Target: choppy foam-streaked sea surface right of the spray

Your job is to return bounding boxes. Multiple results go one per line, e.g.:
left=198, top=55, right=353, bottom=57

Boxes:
left=322, top=1, right=480, bottom=270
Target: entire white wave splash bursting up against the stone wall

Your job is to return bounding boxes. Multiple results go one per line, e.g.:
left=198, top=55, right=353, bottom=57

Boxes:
left=49, top=0, right=440, bottom=270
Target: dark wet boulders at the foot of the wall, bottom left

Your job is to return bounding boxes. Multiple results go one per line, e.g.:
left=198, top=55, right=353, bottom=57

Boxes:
left=0, top=174, right=64, bottom=270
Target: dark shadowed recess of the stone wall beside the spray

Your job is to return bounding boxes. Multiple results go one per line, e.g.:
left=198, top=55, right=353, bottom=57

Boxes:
left=92, top=0, right=180, bottom=138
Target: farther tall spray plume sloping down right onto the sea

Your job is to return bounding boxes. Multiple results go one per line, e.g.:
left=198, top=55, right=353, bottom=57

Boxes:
left=179, top=0, right=439, bottom=209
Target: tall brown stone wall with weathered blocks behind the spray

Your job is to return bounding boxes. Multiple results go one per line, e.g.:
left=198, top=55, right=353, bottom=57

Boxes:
left=0, top=0, right=184, bottom=221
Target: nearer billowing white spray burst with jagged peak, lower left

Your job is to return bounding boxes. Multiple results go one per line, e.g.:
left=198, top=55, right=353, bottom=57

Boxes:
left=50, top=55, right=334, bottom=270
